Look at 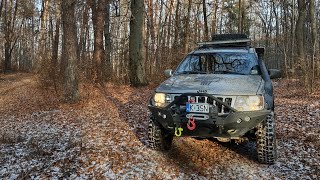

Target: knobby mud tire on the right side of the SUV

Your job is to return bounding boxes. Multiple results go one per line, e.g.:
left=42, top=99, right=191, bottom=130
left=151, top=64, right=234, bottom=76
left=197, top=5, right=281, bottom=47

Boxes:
left=256, top=112, right=277, bottom=164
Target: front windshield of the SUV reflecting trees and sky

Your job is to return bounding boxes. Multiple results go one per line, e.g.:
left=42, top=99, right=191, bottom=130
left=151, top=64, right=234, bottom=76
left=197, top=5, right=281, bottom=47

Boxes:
left=175, top=52, right=260, bottom=75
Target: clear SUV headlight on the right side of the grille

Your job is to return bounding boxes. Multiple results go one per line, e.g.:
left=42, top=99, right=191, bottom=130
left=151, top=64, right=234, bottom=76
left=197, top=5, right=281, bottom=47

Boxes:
left=234, top=96, right=264, bottom=111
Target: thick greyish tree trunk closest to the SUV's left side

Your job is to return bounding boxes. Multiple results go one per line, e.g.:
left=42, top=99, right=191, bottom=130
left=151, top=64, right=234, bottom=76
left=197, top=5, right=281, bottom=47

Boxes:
left=129, top=0, right=147, bottom=86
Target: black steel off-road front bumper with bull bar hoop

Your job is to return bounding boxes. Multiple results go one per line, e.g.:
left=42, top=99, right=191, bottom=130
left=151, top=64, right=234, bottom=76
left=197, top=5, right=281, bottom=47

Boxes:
left=148, top=93, right=270, bottom=138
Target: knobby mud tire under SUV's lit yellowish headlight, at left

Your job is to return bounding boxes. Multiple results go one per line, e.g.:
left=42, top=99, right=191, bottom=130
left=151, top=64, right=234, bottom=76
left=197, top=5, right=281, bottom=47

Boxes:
left=148, top=118, right=173, bottom=151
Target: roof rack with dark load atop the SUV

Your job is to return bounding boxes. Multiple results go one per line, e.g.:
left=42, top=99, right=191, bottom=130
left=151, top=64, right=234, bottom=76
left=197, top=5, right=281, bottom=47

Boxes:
left=198, top=34, right=251, bottom=48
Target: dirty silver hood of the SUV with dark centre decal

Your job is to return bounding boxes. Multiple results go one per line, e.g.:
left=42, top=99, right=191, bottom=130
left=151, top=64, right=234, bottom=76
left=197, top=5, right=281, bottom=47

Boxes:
left=156, top=74, right=263, bottom=95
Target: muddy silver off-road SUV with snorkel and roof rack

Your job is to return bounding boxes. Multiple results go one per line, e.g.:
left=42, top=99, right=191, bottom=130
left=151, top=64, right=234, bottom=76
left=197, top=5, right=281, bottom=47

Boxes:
left=148, top=34, right=280, bottom=164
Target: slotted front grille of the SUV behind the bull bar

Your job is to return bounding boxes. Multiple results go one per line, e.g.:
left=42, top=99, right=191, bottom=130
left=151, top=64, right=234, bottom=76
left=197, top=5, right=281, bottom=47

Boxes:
left=171, top=94, right=235, bottom=115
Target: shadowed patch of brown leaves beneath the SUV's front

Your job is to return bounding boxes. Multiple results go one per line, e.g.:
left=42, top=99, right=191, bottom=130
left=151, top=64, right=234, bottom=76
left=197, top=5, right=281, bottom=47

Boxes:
left=165, top=138, right=257, bottom=176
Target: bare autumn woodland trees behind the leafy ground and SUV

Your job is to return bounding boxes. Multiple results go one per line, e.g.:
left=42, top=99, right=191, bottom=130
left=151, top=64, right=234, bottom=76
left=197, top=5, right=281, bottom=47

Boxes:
left=0, top=0, right=320, bottom=101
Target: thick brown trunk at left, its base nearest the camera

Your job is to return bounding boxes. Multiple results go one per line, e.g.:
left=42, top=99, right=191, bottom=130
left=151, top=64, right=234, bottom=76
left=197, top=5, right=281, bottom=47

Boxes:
left=61, top=0, right=80, bottom=102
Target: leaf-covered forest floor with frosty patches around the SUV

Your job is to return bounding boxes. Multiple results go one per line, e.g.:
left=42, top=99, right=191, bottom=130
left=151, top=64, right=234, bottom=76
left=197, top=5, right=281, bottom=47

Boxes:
left=0, top=74, right=320, bottom=179
